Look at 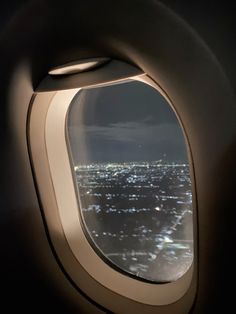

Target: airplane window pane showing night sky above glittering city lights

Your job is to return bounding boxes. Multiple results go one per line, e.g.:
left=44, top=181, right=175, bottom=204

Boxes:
left=66, top=80, right=193, bottom=283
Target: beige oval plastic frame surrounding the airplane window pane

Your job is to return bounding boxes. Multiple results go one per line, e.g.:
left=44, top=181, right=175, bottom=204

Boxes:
left=28, top=60, right=197, bottom=306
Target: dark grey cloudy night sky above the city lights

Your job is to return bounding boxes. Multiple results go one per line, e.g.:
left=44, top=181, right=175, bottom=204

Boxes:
left=67, top=81, right=187, bottom=165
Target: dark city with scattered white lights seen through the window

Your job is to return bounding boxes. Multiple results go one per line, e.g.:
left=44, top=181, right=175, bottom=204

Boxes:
left=74, top=160, right=193, bottom=282
